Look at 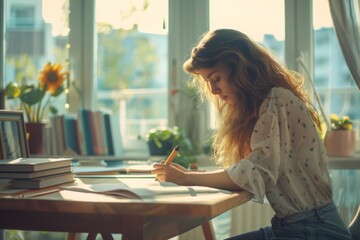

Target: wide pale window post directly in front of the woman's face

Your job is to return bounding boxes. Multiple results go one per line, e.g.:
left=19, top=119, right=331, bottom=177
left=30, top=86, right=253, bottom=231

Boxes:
left=168, top=0, right=209, bottom=151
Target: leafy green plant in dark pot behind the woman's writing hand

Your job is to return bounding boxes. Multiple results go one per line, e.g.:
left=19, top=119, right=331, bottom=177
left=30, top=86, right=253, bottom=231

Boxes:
left=146, top=126, right=196, bottom=168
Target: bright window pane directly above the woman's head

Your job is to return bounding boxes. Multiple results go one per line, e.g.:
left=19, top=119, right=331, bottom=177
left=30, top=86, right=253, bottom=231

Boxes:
left=210, top=0, right=285, bottom=128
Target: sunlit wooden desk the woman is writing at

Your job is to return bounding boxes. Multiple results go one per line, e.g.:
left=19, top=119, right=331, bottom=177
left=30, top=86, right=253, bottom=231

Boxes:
left=0, top=178, right=250, bottom=240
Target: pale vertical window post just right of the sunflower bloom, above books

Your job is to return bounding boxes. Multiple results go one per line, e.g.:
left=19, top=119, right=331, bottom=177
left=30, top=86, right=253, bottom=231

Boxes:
left=69, top=0, right=97, bottom=112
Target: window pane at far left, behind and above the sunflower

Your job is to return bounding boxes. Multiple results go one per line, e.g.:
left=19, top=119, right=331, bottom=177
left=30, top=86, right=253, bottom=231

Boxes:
left=3, top=0, right=69, bottom=118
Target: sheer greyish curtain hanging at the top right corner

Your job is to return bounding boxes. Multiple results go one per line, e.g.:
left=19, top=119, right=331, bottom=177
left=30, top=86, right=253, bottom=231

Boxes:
left=329, top=0, right=360, bottom=89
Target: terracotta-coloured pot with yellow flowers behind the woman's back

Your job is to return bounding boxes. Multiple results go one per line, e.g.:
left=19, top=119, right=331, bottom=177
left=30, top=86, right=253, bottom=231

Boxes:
left=324, top=114, right=356, bottom=157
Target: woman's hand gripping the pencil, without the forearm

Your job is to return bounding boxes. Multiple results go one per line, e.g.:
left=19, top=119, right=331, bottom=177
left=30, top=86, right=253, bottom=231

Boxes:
left=151, top=163, right=189, bottom=185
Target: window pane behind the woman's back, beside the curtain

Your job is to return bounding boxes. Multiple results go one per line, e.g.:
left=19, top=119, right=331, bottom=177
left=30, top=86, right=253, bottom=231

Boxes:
left=313, top=0, right=360, bottom=120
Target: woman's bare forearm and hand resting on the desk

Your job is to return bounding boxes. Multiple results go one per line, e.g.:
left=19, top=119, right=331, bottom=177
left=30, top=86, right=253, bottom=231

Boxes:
left=152, top=163, right=242, bottom=191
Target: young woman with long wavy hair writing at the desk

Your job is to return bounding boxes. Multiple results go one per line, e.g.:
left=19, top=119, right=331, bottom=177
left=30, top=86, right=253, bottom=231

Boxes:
left=153, top=29, right=352, bottom=240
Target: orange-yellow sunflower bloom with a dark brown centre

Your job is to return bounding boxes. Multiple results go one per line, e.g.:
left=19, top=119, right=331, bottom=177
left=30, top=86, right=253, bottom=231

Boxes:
left=39, top=63, right=67, bottom=94
